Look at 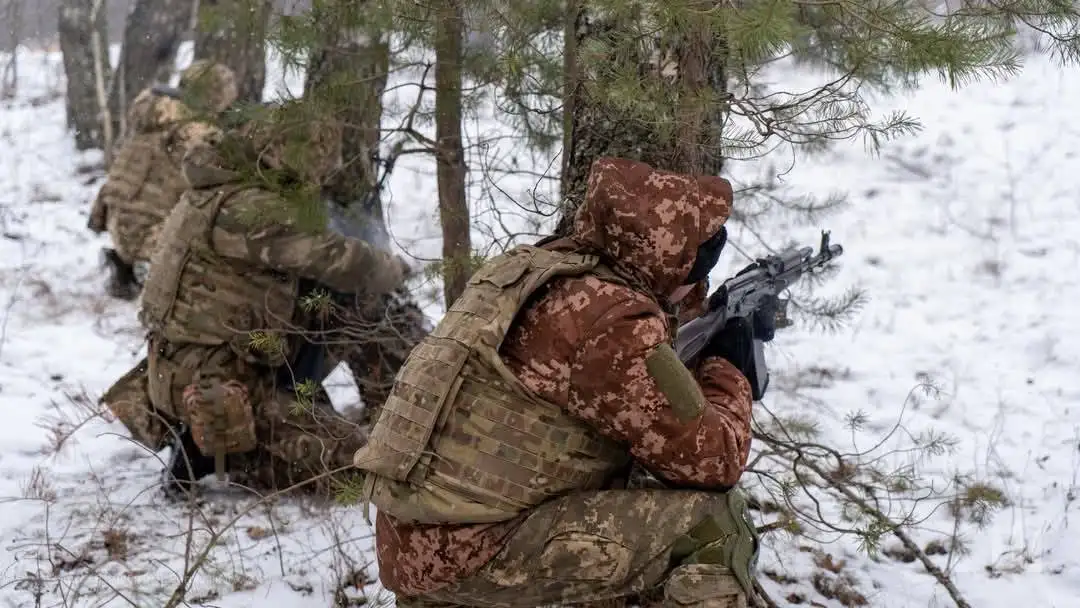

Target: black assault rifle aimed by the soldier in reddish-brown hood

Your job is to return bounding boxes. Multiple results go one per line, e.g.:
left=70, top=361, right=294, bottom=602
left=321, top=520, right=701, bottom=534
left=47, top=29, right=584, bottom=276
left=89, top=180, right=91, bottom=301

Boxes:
left=675, top=231, right=843, bottom=401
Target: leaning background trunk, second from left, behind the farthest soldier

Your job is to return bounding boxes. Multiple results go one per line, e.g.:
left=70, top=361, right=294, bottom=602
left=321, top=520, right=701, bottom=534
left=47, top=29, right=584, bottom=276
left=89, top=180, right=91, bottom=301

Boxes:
left=109, top=0, right=194, bottom=146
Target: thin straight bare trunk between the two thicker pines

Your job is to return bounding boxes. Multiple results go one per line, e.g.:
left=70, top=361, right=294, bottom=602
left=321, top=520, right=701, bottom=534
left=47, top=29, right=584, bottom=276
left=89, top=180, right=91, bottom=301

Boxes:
left=435, top=0, right=472, bottom=308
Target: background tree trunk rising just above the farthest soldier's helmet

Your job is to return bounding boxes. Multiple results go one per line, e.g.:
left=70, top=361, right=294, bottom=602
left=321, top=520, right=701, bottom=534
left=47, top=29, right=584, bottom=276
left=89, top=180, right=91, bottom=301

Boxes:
left=195, top=0, right=273, bottom=102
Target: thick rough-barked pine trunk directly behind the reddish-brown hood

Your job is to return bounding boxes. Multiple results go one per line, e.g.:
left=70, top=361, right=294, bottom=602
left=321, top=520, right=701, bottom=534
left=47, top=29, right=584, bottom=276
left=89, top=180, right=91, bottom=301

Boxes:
left=556, top=0, right=726, bottom=234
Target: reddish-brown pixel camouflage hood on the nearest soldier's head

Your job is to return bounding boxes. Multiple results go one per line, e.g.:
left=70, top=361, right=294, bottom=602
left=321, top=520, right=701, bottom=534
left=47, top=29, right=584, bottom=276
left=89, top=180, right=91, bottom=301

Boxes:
left=572, top=158, right=732, bottom=297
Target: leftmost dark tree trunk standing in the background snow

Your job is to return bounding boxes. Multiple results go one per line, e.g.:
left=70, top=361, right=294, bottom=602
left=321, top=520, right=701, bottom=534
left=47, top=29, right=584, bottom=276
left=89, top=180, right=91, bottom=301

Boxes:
left=57, top=0, right=111, bottom=150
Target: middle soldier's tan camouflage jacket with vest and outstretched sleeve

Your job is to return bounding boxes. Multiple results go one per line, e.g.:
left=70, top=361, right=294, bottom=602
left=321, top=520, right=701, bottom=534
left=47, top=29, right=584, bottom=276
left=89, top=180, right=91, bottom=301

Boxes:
left=139, top=137, right=402, bottom=365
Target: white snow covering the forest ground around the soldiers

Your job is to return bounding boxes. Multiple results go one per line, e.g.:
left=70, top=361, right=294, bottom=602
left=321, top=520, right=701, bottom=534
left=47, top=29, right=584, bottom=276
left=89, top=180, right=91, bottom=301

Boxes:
left=0, top=42, right=1080, bottom=608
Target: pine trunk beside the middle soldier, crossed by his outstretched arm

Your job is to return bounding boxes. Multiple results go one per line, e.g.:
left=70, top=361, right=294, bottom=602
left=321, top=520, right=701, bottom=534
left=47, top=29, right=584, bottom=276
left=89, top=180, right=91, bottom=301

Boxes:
left=305, top=0, right=428, bottom=418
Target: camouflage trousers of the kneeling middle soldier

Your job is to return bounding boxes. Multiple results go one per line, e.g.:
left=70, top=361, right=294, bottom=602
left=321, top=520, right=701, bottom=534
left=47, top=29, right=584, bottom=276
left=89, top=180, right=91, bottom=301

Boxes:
left=148, top=340, right=367, bottom=491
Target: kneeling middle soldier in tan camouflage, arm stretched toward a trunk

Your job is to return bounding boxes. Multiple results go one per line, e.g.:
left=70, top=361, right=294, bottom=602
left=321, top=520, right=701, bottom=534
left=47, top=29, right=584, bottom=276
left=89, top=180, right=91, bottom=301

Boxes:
left=103, top=103, right=407, bottom=490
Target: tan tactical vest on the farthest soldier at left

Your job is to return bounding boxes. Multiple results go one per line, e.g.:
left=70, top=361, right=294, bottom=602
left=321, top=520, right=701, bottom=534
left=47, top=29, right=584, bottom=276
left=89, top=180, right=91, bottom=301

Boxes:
left=100, top=127, right=188, bottom=261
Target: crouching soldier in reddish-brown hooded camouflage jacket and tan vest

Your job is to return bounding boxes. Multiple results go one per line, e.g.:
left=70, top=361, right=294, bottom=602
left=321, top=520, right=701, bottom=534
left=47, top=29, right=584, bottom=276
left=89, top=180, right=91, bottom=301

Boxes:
left=354, top=159, right=757, bottom=608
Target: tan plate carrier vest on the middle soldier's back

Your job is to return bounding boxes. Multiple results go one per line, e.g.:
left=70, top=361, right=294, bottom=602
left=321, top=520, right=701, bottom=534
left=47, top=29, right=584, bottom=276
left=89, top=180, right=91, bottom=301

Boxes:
left=139, top=187, right=298, bottom=366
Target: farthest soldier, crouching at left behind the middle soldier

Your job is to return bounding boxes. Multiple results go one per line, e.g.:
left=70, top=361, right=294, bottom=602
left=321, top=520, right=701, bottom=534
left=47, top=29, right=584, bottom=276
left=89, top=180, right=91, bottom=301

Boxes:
left=89, top=60, right=238, bottom=299
